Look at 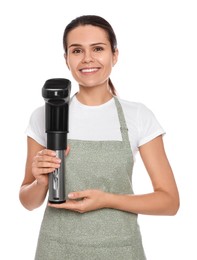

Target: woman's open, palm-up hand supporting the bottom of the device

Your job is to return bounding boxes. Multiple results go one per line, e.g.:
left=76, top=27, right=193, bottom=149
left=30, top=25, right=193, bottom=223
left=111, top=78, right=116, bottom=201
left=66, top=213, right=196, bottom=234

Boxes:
left=48, top=190, right=108, bottom=213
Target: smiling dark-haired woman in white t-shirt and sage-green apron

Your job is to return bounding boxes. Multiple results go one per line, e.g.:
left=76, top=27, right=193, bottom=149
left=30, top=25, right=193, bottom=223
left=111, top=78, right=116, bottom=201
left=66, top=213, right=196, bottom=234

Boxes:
left=20, top=15, right=179, bottom=260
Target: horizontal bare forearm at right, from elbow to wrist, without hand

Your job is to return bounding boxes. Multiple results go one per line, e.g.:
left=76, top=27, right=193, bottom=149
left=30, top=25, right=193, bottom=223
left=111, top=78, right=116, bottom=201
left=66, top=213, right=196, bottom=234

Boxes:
left=106, top=191, right=179, bottom=215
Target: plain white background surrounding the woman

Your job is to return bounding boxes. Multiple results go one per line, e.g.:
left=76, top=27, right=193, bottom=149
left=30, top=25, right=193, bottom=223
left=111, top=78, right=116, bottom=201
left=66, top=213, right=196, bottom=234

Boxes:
left=0, top=0, right=197, bottom=260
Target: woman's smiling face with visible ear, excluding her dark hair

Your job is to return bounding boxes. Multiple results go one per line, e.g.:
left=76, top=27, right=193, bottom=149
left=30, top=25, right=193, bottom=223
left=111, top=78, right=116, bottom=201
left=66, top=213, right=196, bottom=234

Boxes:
left=65, top=25, right=118, bottom=87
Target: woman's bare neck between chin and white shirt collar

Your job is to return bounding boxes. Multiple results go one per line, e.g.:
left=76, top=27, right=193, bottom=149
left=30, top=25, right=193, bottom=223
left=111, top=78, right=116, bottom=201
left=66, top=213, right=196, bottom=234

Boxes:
left=76, top=87, right=113, bottom=106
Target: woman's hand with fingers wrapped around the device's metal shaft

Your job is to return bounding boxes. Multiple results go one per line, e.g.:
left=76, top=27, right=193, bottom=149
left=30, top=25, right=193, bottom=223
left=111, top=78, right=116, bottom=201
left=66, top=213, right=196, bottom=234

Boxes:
left=32, top=149, right=61, bottom=186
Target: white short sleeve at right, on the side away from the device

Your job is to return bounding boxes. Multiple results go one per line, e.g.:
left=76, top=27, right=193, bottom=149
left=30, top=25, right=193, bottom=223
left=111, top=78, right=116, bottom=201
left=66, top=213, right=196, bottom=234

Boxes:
left=137, top=104, right=165, bottom=147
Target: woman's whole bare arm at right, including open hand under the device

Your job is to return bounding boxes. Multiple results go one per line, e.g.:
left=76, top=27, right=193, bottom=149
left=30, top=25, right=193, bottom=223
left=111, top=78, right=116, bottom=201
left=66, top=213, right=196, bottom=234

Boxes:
left=50, top=136, right=179, bottom=215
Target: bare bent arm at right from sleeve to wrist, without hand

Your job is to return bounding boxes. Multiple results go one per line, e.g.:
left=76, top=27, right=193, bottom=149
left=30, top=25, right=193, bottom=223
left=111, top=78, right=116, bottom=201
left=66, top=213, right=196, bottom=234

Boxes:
left=106, top=136, right=179, bottom=215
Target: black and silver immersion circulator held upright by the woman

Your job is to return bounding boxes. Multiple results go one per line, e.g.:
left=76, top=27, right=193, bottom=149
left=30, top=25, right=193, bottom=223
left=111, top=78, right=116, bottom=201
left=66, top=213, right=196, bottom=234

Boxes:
left=42, top=78, right=71, bottom=203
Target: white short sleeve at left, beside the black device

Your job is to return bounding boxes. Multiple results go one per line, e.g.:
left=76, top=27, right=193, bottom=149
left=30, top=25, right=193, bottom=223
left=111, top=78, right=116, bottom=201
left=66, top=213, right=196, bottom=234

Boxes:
left=25, top=106, right=46, bottom=147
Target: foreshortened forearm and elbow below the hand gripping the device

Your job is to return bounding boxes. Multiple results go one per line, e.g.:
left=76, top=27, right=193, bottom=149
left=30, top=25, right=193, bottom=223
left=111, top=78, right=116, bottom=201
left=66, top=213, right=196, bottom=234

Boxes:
left=19, top=180, right=48, bottom=210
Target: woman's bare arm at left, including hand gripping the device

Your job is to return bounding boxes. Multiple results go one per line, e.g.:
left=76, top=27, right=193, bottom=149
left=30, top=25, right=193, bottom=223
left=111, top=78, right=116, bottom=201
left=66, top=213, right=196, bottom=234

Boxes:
left=19, top=137, right=60, bottom=210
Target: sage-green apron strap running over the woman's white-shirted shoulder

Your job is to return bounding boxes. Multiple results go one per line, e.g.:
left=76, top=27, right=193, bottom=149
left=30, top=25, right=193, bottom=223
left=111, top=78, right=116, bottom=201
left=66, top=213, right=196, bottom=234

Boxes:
left=114, top=96, right=130, bottom=146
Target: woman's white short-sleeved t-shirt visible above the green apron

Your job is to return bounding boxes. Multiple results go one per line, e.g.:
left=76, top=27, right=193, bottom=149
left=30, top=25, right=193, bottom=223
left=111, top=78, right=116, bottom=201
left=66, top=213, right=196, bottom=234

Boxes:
left=26, top=96, right=164, bottom=157
